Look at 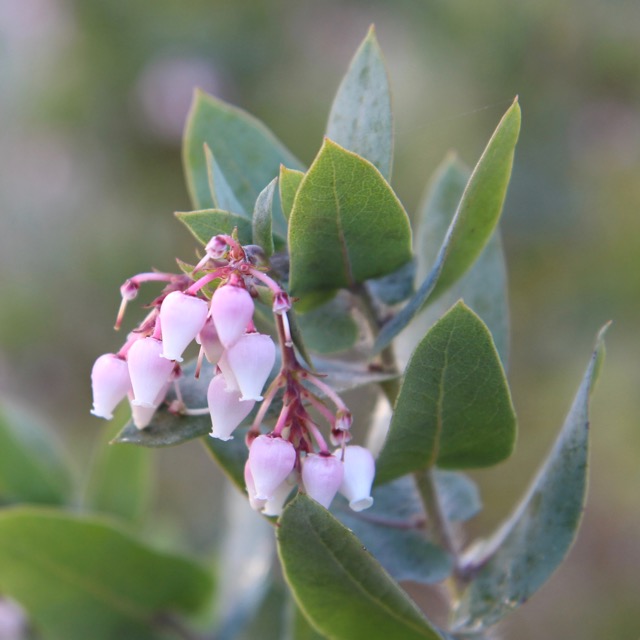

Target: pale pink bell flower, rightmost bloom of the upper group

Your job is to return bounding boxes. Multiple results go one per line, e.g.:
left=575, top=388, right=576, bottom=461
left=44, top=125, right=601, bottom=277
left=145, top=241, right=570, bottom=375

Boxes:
left=225, top=333, right=276, bottom=401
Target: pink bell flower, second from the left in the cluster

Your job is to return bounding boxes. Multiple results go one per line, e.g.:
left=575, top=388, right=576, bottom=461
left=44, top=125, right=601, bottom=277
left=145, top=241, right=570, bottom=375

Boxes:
left=127, top=338, right=174, bottom=407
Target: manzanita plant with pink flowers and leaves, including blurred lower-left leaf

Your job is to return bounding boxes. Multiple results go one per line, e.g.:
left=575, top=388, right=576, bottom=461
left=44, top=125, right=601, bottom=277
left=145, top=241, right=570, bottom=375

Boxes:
left=0, top=29, right=604, bottom=640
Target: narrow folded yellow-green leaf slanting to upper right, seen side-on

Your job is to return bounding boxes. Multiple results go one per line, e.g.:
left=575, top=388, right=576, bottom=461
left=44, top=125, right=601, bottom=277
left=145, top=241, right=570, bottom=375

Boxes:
left=374, top=100, right=520, bottom=352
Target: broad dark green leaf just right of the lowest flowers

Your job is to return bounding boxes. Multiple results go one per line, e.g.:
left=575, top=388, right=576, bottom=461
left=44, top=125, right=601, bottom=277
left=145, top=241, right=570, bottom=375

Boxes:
left=376, top=302, right=516, bottom=483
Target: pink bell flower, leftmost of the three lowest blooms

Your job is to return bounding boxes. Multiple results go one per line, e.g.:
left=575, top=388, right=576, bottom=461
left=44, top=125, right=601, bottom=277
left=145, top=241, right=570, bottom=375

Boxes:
left=249, top=435, right=296, bottom=500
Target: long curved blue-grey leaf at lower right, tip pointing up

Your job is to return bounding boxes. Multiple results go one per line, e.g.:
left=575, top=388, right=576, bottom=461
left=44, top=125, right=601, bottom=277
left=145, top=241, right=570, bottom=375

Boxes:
left=455, top=327, right=607, bottom=631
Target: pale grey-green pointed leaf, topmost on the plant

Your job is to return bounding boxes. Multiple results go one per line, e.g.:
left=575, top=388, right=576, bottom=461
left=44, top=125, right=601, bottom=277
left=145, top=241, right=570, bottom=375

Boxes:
left=326, top=26, right=393, bottom=180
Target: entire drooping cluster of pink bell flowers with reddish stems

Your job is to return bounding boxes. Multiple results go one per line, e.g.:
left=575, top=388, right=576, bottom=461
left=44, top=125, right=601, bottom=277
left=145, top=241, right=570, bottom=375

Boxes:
left=91, top=235, right=375, bottom=515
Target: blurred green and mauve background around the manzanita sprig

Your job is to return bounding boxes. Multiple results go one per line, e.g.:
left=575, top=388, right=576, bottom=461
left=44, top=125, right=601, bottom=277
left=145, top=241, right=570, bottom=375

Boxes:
left=0, top=0, right=640, bottom=640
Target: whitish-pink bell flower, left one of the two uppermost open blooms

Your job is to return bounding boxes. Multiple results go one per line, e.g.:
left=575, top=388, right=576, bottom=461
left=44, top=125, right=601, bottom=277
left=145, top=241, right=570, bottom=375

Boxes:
left=160, top=291, right=209, bottom=362
